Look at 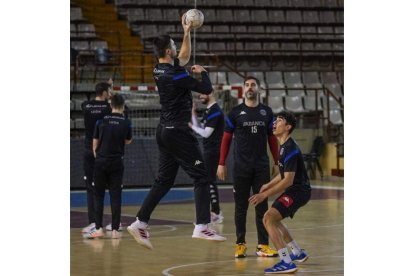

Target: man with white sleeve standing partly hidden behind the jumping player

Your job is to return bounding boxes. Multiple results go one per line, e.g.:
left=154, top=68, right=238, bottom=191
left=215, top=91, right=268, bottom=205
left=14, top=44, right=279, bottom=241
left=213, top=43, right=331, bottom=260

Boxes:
left=188, top=94, right=224, bottom=223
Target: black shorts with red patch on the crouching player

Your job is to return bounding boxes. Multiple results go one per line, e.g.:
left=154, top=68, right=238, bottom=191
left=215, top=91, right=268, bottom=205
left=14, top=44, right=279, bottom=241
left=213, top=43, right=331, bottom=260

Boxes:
left=272, top=186, right=311, bottom=218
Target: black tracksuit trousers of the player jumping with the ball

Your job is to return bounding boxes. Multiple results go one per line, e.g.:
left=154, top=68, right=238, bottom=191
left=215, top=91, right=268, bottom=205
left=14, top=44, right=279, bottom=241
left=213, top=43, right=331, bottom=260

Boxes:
left=137, top=124, right=210, bottom=224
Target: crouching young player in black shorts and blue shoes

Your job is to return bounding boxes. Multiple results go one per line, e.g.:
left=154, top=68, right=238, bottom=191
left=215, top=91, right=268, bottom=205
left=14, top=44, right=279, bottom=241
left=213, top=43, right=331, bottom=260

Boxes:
left=249, top=111, right=311, bottom=274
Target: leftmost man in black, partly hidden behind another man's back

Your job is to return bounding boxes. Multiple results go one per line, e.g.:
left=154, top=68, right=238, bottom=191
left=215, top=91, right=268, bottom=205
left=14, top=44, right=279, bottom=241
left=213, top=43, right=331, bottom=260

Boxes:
left=82, top=82, right=111, bottom=233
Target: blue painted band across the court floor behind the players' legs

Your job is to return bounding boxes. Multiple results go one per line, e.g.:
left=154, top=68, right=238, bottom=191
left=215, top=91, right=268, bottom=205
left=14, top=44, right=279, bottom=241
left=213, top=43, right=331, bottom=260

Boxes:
left=70, top=189, right=194, bottom=208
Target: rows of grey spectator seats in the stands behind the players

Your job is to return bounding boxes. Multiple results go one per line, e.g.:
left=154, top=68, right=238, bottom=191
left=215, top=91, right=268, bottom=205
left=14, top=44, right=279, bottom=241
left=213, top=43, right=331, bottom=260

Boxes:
left=70, top=0, right=344, bottom=134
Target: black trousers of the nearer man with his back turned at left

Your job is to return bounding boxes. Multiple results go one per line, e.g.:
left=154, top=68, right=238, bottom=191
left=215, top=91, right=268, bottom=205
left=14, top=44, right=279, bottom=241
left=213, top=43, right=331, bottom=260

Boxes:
left=94, top=157, right=124, bottom=230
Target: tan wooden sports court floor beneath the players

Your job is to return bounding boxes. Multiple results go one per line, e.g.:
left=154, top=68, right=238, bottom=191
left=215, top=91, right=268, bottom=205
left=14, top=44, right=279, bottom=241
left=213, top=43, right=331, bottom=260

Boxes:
left=70, top=178, right=344, bottom=276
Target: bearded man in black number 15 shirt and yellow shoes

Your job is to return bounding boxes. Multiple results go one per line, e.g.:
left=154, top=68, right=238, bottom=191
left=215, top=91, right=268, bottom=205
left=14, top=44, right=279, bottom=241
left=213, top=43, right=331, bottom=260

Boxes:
left=217, top=77, right=278, bottom=258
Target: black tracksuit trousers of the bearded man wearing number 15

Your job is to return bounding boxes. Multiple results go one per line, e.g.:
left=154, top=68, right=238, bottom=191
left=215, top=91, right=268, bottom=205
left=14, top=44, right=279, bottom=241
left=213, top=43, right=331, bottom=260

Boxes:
left=233, top=164, right=270, bottom=245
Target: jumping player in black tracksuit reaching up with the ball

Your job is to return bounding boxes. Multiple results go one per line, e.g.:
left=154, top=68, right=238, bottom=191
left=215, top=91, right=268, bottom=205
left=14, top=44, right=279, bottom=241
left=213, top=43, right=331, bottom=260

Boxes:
left=127, top=15, right=225, bottom=249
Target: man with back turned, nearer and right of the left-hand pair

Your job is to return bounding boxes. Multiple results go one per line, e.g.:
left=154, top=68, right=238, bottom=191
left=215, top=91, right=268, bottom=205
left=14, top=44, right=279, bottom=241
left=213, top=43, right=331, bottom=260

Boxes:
left=84, top=94, right=132, bottom=239
